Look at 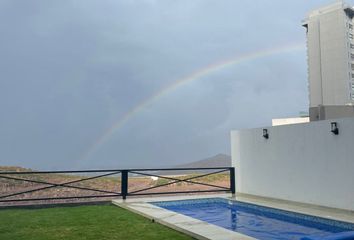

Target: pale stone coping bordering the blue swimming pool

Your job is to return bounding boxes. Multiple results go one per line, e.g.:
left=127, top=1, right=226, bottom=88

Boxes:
left=112, top=194, right=354, bottom=240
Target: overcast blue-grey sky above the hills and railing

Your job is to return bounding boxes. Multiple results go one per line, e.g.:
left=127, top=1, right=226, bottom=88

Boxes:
left=0, top=0, right=353, bottom=170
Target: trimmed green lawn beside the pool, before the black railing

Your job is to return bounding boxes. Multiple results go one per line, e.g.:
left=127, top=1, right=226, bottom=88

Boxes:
left=0, top=205, right=193, bottom=240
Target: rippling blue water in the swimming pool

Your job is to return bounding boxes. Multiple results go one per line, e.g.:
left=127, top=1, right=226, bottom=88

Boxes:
left=152, top=198, right=354, bottom=240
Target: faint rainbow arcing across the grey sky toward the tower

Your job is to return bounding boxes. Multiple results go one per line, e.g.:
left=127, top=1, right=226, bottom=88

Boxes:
left=80, top=43, right=305, bottom=160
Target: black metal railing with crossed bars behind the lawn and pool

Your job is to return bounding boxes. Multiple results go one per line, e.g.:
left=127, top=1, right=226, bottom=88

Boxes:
left=0, top=167, right=236, bottom=202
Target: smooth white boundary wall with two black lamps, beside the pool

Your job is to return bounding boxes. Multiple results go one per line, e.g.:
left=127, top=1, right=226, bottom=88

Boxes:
left=231, top=118, right=354, bottom=210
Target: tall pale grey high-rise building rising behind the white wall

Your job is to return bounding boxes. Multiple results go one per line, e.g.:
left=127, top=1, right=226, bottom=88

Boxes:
left=303, top=2, right=354, bottom=121
